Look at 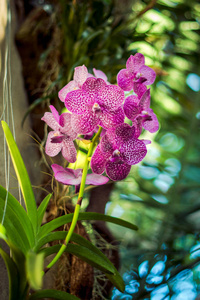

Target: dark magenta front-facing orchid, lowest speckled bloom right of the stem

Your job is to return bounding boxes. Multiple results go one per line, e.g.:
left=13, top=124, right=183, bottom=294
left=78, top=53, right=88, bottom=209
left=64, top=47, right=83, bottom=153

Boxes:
left=91, top=123, right=147, bottom=181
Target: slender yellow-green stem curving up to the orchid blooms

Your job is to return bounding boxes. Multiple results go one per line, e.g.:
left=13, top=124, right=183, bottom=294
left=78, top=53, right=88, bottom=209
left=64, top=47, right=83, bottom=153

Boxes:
left=45, top=127, right=102, bottom=273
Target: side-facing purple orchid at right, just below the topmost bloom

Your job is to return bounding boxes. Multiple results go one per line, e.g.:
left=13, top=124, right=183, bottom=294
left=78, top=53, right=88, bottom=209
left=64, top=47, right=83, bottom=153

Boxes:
left=124, top=89, right=159, bottom=136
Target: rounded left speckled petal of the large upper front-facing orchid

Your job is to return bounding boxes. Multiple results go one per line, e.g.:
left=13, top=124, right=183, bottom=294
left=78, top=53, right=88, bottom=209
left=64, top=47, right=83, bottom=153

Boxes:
left=65, top=89, right=91, bottom=115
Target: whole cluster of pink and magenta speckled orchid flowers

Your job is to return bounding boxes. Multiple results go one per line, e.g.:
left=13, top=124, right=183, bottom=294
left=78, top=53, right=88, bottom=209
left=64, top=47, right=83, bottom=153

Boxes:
left=42, top=53, right=159, bottom=186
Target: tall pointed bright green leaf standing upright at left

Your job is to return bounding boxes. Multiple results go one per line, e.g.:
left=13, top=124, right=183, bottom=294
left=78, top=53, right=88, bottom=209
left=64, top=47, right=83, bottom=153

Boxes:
left=1, top=121, right=38, bottom=233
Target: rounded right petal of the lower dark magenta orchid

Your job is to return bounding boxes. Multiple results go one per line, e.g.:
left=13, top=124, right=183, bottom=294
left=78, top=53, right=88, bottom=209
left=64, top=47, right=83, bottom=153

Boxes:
left=120, top=139, right=147, bottom=165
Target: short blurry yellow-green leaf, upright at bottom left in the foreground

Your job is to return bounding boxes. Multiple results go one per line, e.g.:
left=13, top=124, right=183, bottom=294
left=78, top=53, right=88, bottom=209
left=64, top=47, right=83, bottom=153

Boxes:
left=26, top=251, right=44, bottom=290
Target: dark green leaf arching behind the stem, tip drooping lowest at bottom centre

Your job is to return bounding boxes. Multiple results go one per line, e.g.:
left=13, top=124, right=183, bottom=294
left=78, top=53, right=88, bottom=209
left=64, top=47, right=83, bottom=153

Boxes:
left=35, top=231, right=125, bottom=292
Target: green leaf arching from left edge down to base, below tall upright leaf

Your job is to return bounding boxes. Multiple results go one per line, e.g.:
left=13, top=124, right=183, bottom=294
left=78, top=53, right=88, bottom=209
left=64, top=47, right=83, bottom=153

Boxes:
left=0, top=186, right=35, bottom=248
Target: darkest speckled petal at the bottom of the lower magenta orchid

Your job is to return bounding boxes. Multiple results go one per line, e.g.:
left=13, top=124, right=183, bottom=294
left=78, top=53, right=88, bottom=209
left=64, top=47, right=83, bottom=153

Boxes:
left=106, top=160, right=131, bottom=181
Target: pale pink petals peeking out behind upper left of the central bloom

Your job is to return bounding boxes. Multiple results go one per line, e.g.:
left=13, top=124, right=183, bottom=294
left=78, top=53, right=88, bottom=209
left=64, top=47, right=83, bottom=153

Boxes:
left=58, top=65, right=88, bottom=102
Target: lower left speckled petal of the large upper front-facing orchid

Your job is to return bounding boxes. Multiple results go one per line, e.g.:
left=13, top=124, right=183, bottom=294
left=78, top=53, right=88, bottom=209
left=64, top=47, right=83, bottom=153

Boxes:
left=71, top=111, right=99, bottom=134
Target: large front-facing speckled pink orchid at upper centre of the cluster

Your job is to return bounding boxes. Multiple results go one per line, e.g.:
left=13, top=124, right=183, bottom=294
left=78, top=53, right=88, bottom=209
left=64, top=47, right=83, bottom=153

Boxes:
left=65, top=77, right=125, bottom=134
